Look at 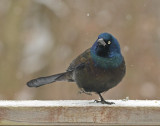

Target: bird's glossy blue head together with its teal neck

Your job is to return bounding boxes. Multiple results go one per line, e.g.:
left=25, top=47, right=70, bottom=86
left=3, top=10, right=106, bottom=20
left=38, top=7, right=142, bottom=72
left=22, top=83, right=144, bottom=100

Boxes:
left=91, top=33, right=123, bottom=67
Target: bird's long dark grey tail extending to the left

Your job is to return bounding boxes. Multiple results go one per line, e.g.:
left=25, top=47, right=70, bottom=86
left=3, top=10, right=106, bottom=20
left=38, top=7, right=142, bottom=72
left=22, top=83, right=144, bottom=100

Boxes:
left=27, top=71, right=72, bottom=87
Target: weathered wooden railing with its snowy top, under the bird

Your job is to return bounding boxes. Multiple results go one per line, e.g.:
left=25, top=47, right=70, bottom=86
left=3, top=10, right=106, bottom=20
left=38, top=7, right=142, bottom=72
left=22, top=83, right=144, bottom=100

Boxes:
left=0, top=100, right=160, bottom=125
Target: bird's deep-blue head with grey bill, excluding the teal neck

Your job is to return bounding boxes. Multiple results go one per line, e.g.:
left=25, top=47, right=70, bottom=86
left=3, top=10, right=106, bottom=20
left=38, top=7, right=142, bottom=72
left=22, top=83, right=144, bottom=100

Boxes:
left=92, top=33, right=121, bottom=58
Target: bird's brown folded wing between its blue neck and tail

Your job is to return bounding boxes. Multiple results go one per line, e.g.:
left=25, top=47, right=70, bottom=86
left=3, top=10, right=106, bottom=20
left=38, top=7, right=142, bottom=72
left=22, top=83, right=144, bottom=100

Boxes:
left=67, top=48, right=91, bottom=71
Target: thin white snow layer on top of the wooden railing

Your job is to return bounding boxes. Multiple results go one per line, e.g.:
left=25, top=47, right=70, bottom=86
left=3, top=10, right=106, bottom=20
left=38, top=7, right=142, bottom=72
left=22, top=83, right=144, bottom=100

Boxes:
left=0, top=100, right=160, bottom=107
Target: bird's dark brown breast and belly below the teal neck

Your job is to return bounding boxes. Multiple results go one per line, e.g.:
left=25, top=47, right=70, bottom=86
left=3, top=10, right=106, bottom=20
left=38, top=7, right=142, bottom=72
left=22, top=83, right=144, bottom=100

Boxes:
left=74, top=57, right=125, bottom=92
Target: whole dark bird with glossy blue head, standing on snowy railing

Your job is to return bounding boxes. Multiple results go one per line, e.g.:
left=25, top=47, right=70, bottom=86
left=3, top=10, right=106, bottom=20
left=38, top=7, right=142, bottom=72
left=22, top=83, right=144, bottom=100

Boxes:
left=27, top=32, right=126, bottom=105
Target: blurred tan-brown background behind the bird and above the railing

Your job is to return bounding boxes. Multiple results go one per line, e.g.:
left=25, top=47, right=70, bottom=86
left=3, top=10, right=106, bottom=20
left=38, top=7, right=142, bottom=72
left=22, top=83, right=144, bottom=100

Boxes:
left=0, top=0, right=160, bottom=100
